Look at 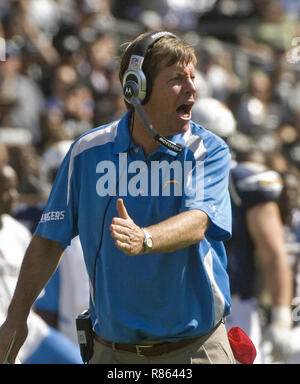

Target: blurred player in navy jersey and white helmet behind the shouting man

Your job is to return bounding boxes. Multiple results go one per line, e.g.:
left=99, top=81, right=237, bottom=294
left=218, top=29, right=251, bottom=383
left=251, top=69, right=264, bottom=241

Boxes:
left=193, top=98, right=292, bottom=363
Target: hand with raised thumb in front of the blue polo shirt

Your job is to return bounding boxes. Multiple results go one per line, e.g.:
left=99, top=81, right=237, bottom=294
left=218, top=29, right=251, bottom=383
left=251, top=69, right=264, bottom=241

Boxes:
left=110, top=199, right=144, bottom=256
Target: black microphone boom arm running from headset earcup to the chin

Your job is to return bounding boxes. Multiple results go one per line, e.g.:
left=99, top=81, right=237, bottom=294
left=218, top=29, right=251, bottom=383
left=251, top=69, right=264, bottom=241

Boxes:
left=123, top=80, right=183, bottom=153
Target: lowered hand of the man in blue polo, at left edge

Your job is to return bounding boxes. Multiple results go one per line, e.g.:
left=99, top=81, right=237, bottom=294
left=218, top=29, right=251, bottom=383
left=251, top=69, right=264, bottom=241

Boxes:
left=0, top=321, right=28, bottom=364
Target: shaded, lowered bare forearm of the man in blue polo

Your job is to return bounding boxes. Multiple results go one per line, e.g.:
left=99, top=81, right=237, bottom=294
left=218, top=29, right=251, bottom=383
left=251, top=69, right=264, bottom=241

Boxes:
left=8, top=235, right=62, bottom=322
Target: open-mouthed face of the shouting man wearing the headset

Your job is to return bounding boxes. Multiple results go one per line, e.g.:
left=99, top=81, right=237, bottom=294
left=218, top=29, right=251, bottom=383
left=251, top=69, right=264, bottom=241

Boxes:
left=144, top=62, right=196, bottom=137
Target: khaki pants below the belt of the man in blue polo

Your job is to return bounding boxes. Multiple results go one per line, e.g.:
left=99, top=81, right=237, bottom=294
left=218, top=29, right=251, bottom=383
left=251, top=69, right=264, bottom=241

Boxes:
left=89, top=323, right=235, bottom=364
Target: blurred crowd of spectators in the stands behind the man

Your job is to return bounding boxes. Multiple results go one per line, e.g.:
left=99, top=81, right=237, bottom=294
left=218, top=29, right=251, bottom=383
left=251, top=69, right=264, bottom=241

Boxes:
left=0, top=0, right=300, bottom=364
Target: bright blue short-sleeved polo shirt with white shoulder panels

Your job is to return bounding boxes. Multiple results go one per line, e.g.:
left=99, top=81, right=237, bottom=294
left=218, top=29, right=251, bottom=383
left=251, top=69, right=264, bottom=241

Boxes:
left=36, top=113, right=231, bottom=343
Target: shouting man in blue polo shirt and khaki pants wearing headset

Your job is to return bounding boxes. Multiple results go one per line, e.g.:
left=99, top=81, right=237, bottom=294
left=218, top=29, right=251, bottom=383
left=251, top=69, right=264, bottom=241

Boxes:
left=0, top=33, right=234, bottom=364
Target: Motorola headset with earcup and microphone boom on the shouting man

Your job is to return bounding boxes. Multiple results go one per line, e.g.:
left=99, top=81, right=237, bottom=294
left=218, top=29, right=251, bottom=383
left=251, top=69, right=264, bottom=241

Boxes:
left=123, top=31, right=183, bottom=153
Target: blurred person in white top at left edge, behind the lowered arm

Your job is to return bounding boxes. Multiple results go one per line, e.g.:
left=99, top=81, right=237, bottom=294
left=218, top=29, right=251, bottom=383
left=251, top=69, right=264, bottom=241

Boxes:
left=0, top=164, right=82, bottom=364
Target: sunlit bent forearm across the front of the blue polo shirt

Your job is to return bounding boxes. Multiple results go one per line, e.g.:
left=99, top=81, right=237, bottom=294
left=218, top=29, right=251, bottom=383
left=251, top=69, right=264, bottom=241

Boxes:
left=146, top=210, right=209, bottom=253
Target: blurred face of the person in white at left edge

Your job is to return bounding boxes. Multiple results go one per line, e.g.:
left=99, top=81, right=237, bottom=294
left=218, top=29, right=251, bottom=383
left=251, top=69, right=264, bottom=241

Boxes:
left=0, top=166, right=18, bottom=215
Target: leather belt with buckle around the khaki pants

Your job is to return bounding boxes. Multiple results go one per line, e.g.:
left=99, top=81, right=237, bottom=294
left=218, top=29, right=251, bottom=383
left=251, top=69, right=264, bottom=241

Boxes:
left=94, top=322, right=221, bottom=357
